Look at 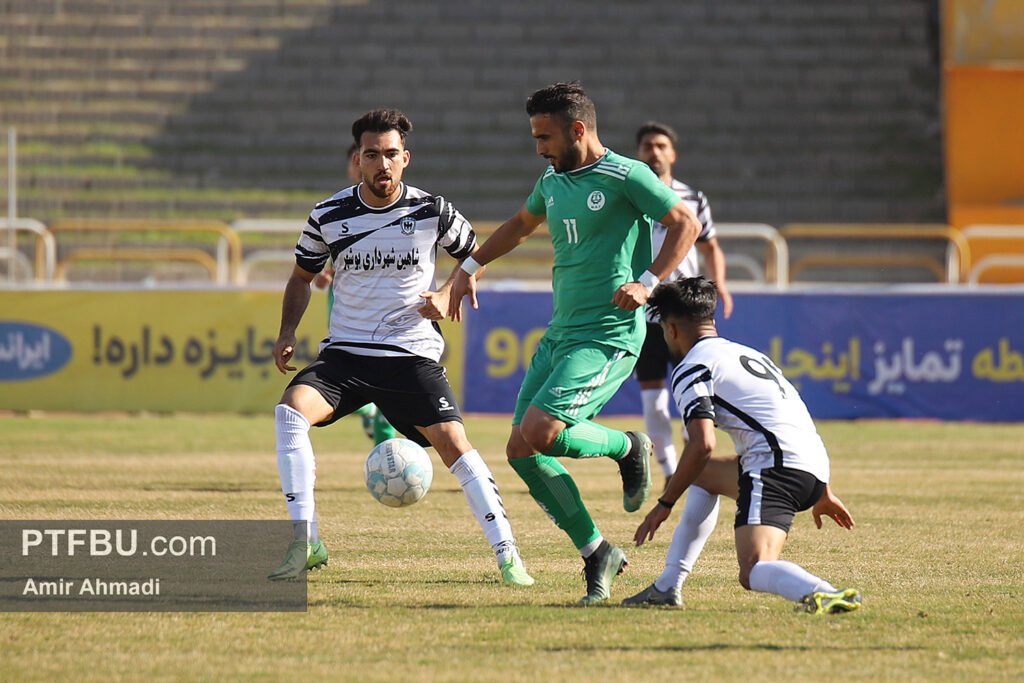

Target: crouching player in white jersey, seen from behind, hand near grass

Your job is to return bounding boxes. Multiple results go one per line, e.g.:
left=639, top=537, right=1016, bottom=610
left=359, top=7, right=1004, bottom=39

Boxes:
left=623, top=278, right=860, bottom=613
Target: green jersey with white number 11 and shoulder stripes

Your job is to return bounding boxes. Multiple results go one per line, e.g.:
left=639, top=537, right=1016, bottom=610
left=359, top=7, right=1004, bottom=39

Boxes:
left=526, top=150, right=680, bottom=355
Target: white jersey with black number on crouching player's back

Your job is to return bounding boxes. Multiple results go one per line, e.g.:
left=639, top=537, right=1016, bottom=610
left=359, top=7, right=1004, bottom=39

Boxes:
left=672, top=337, right=829, bottom=483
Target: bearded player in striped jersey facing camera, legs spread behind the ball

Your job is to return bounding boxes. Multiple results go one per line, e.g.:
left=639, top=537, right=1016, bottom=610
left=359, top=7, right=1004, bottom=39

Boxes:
left=269, top=110, right=534, bottom=586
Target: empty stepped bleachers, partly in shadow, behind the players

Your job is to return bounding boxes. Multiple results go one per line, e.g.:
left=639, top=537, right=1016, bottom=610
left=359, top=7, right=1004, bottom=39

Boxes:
left=0, top=0, right=945, bottom=225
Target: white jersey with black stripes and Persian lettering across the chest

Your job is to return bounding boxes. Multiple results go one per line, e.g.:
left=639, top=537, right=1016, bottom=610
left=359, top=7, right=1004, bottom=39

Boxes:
left=295, top=184, right=476, bottom=361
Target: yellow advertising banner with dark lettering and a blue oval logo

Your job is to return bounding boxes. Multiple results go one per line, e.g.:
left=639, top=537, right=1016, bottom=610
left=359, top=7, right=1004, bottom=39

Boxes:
left=0, top=290, right=463, bottom=413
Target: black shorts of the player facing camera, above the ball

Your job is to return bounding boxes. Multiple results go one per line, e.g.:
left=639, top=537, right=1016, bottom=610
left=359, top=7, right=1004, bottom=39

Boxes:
left=288, top=349, right=462, bottom=446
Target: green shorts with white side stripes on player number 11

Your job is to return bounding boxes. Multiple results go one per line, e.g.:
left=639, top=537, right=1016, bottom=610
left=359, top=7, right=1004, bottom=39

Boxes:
left=512, top=335, right=637, bottom=425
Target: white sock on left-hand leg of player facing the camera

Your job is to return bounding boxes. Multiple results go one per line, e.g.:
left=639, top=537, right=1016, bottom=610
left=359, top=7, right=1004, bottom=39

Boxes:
left=273, top=403, right=319, bottom=543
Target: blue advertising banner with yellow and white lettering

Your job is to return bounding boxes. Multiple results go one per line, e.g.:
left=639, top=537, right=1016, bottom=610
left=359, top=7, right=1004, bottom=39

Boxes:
left=464, top=292, right=1024, bottom=422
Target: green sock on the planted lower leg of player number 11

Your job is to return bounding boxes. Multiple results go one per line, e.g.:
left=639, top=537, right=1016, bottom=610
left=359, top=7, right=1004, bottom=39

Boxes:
left=509, top=454, right=598, bottom=548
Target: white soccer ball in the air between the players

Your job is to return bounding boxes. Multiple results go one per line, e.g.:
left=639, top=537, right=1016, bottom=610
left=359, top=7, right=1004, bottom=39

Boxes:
left=364, top=438, right=434, bottom=508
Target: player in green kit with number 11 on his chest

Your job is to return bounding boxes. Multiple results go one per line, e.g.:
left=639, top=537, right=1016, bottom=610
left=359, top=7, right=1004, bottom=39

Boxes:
left=449, top=82, right=700, bottom=604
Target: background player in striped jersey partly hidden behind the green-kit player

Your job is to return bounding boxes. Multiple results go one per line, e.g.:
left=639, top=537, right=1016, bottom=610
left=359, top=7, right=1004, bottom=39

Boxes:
left=636, top=121, right=732, bottom=482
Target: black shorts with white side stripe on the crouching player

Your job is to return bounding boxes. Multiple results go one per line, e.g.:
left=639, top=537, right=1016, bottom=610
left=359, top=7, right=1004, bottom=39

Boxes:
left=734, top=467, right=825, bottom=533
